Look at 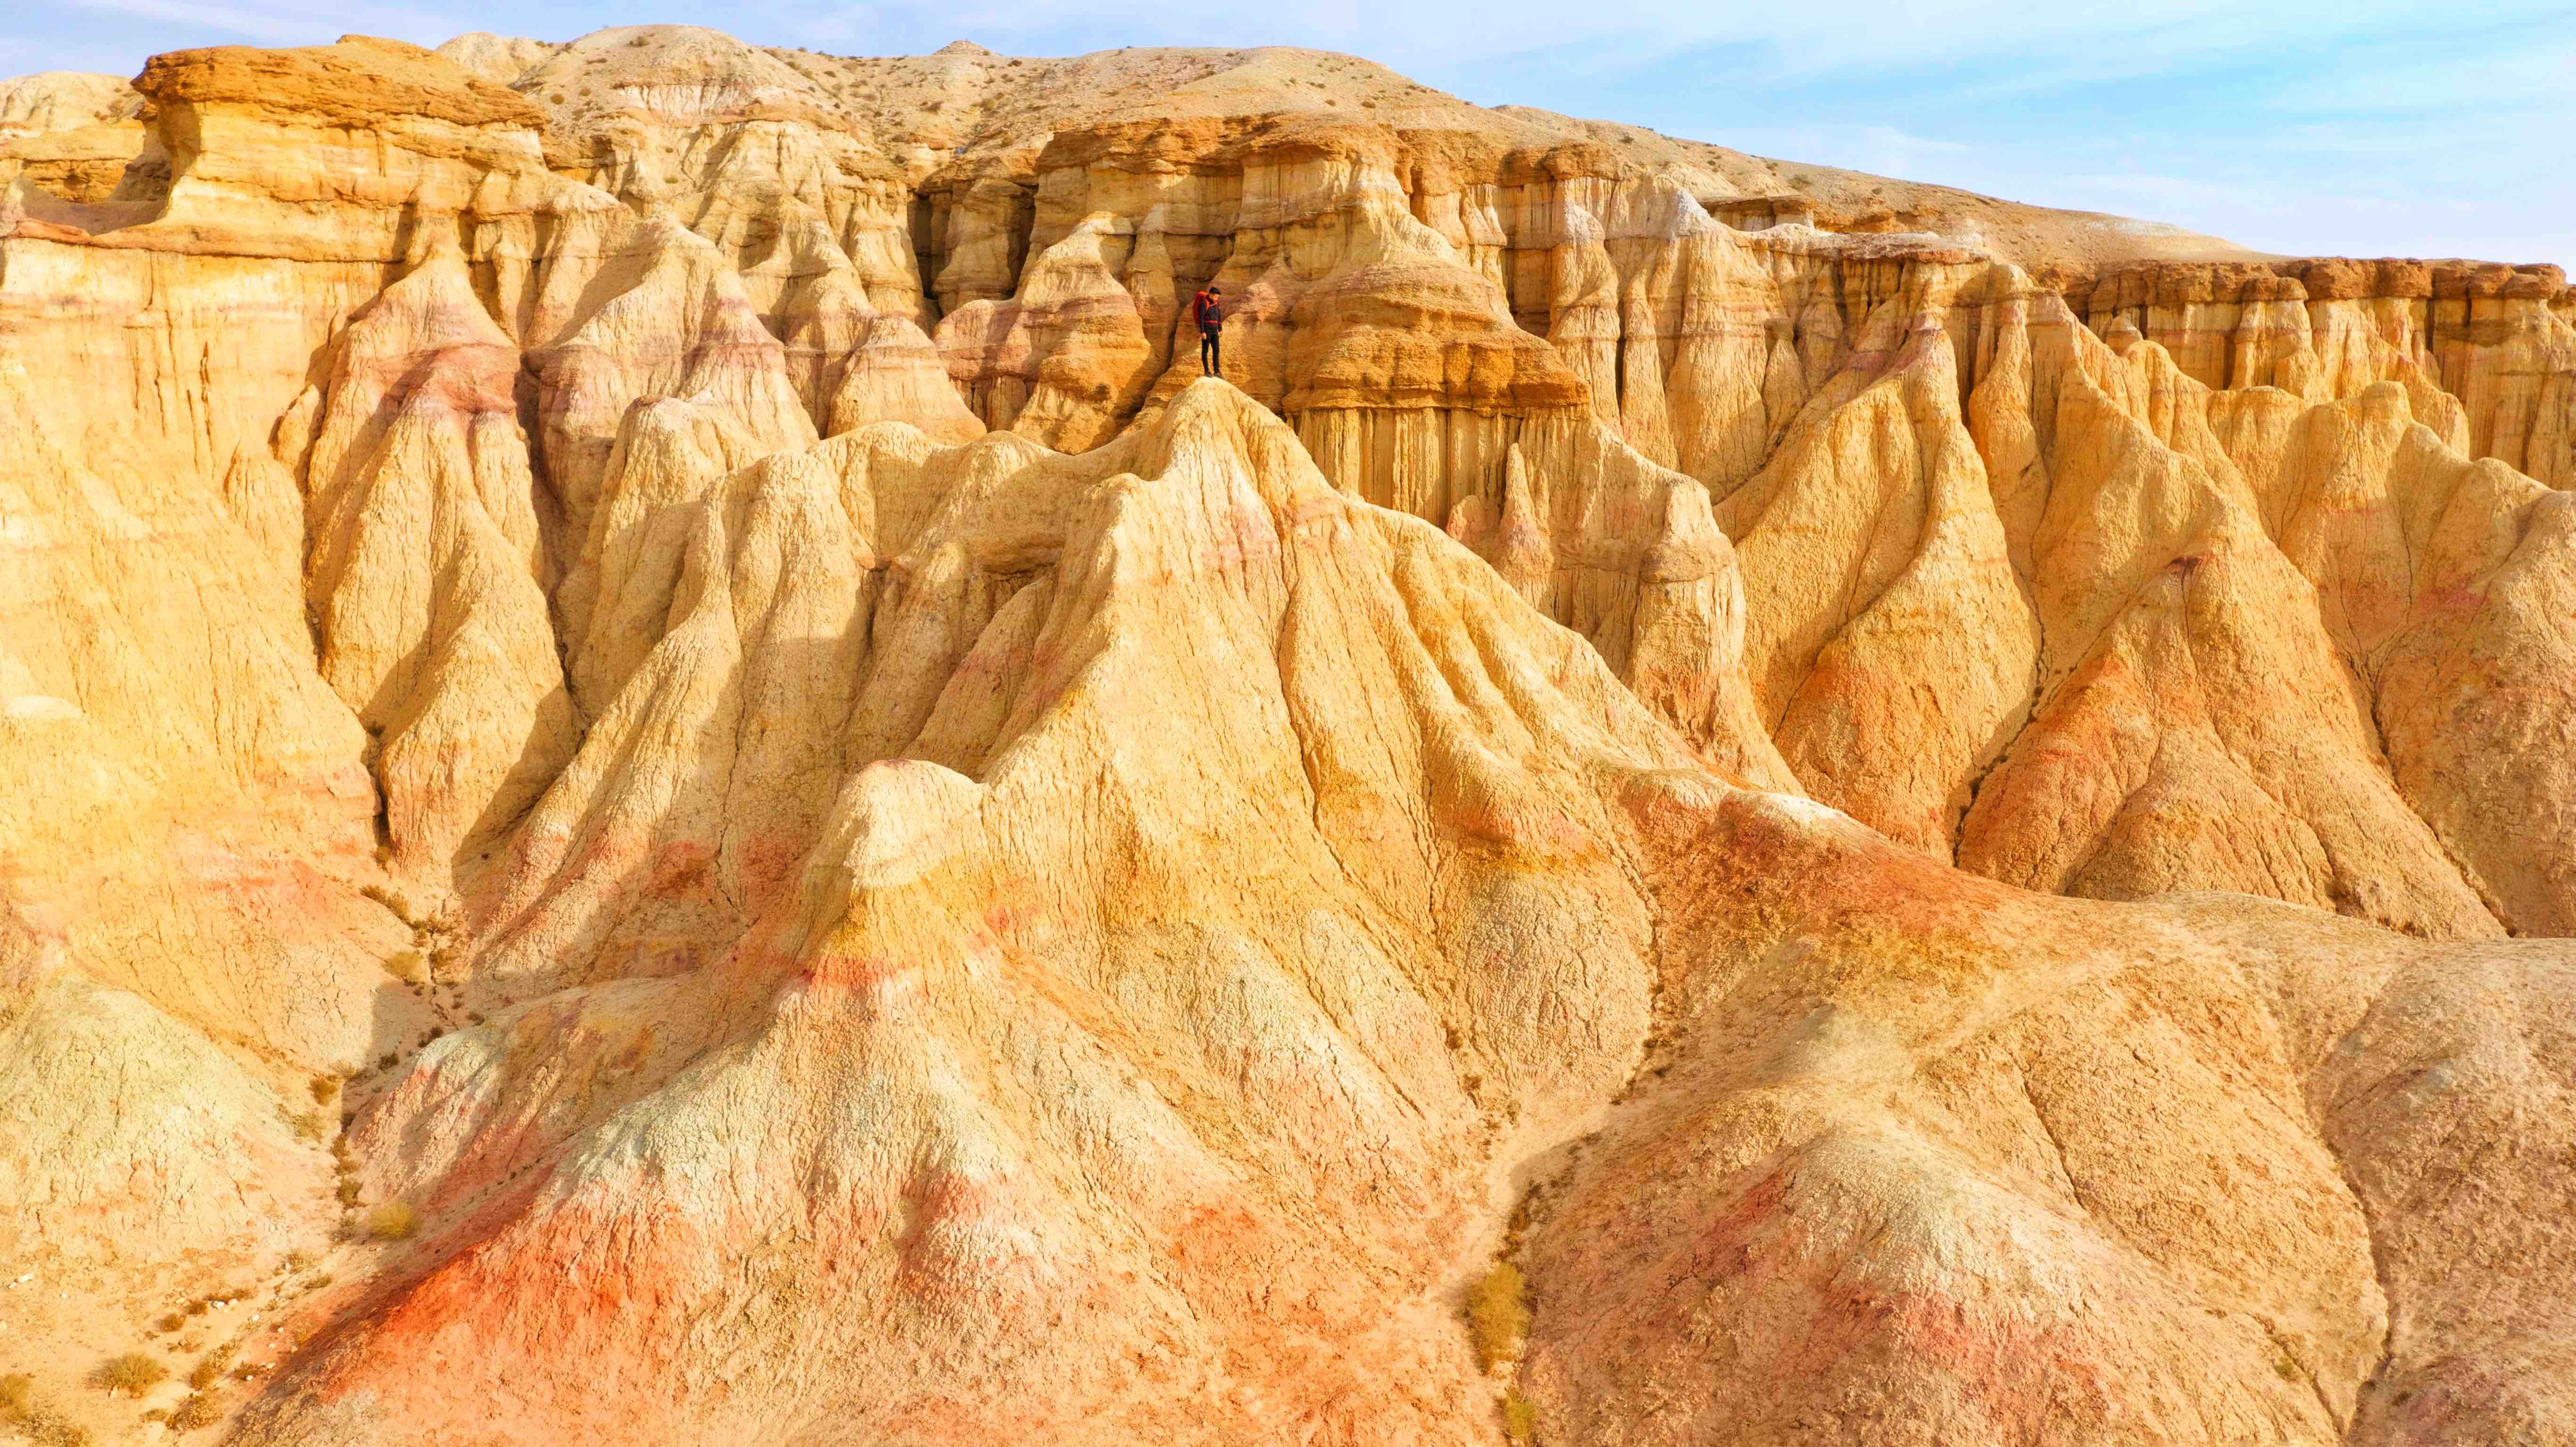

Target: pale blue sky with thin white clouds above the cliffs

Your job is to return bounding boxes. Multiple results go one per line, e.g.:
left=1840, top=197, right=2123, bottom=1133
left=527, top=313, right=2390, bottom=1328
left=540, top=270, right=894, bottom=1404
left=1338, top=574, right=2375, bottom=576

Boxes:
left=0, top=0, right=2576, bottom=271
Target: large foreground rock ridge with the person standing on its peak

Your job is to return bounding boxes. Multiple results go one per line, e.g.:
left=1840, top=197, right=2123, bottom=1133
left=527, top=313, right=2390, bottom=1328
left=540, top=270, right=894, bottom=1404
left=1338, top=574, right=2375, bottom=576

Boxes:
left=231, top=381, right=2540, bottom=1442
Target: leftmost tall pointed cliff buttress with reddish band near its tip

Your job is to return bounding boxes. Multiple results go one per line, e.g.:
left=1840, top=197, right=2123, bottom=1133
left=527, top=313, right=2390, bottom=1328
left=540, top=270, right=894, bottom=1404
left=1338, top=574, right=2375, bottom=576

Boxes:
left=304, top=237, right=577, bottom=868
